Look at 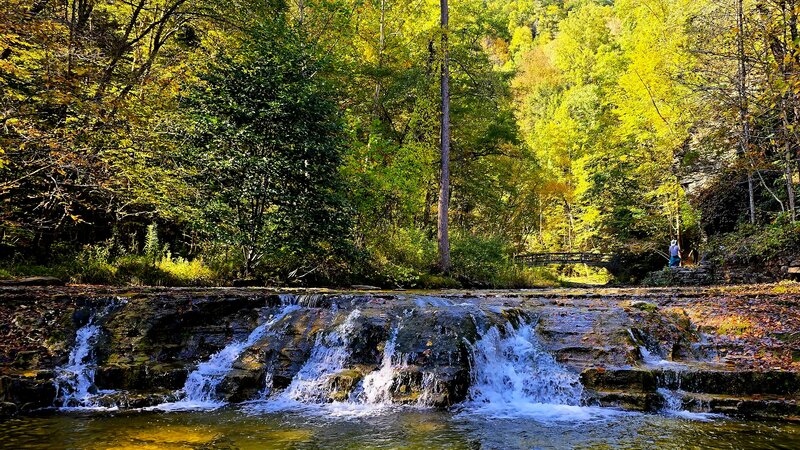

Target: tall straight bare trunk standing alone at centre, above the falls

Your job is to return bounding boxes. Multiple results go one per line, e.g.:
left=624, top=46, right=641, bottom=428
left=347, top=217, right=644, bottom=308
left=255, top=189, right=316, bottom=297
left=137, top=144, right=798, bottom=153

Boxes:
left=438, top=0, right=450, bottom=273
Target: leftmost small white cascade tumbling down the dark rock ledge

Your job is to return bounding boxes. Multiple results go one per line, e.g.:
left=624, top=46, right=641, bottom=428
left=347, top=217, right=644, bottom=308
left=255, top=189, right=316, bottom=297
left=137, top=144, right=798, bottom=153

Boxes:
left=55, top=315, right=113, bottom=409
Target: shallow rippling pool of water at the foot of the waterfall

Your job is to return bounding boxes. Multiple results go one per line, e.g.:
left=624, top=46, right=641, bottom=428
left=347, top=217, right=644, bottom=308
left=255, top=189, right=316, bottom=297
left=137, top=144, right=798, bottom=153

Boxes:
left=0, top=405, right=800, bottom=450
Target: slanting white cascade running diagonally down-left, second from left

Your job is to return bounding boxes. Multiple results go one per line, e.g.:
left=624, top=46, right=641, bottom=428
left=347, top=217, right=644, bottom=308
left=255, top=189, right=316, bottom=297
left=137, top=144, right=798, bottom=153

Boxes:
left=155, top=305, right=300, bottom=410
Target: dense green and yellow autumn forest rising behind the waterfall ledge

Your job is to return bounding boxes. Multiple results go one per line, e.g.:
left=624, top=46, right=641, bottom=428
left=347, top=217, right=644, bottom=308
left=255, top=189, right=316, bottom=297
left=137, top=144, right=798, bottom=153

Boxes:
left=0, top=0, right=800, bottom=288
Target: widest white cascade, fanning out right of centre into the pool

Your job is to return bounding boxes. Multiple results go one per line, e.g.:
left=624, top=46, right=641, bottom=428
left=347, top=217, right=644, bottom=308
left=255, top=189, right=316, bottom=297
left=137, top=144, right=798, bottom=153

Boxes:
left=461, top=324, right=622, bottom=422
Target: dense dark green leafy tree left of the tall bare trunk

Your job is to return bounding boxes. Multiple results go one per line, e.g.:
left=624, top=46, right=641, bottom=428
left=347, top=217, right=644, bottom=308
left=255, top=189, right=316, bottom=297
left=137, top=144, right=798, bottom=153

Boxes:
left=186, top=22, right=348, bottom=279
